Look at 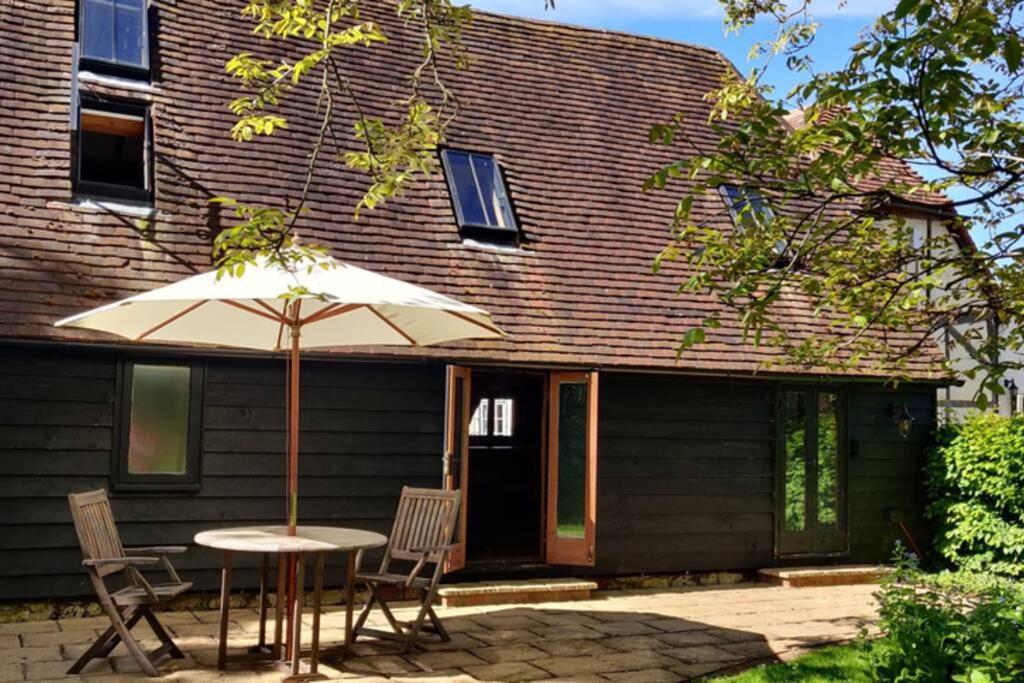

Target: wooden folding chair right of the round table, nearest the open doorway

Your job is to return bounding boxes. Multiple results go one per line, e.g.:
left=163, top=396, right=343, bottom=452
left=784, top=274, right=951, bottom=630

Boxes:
left=352, top=486, right=461, bottom=652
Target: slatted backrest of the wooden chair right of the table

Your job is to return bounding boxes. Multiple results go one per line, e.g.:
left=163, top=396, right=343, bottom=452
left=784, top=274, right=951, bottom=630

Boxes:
left=387, top=486, right=461, bottom=562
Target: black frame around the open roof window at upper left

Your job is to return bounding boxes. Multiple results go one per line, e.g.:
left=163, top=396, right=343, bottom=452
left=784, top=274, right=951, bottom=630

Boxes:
left=72, top=96, right=154, bottom=205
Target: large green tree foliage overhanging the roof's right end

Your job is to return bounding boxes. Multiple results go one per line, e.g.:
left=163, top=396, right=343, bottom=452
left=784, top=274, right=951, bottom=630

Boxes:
left=647, top=0, right=1024, bottom=392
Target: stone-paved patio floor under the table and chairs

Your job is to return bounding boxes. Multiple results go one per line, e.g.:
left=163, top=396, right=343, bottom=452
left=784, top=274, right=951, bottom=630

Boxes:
left=0, top=585, right=877, bottom=683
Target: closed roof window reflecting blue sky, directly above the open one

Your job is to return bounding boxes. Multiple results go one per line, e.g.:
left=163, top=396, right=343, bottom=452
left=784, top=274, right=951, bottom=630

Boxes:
left=78, top=0, right=150, bottom=75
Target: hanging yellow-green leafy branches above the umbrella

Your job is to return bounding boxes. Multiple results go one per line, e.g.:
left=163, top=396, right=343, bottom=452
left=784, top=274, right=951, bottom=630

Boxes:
left=214, top=0, right=471, bottom=274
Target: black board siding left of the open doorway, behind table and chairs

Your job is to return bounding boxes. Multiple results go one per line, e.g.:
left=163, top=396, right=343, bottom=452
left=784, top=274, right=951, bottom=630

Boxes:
left=0, top=349, right=444, bottom=599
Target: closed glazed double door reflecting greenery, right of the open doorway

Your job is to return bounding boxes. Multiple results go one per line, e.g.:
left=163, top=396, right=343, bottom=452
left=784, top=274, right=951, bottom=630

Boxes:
left=776, top=387, right=847, bottom=555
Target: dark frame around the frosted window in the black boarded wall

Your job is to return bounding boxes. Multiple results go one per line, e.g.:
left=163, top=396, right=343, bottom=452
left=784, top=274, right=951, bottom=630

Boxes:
left=111, top=356, right=206, bottom=493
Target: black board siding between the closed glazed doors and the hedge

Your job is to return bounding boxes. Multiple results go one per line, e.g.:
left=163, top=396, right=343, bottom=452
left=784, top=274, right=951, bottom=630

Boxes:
left=848, top=385, right=936, bottom=562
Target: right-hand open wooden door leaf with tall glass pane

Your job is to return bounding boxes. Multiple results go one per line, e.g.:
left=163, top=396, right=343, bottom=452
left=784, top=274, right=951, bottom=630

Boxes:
left=546, top=373, right=597, bottom=566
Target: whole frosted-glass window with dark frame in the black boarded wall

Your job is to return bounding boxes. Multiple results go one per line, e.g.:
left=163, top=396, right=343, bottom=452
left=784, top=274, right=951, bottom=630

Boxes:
left=114, top=360, right=205, bottom=489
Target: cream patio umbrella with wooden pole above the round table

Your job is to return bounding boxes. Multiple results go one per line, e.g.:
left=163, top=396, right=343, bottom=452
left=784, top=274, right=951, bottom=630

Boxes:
left=55, top=257, right=504, bottom=533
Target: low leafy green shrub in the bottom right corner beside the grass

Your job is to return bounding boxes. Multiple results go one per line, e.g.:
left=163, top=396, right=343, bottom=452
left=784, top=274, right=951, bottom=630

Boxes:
left=868, top=560, right=1024, bottom=683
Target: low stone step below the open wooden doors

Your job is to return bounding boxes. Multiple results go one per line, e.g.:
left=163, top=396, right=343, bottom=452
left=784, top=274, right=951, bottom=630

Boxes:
left=437, top=579, right=597, bottom=607
